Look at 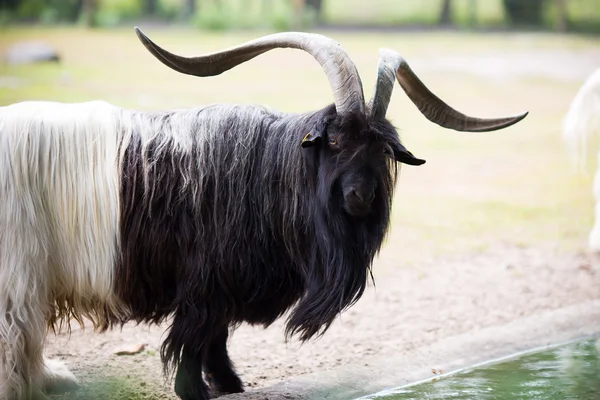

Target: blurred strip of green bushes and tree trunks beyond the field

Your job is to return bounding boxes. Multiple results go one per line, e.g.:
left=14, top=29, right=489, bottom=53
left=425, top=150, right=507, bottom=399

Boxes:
left=0, top=0, right=600, bottom=32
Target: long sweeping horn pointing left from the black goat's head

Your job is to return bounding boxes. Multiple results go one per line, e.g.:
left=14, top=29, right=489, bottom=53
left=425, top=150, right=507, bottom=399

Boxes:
left=135, top=26, right=365, bottom=114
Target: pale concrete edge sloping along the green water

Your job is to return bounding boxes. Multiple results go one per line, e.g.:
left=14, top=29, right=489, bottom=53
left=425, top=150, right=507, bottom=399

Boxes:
left=220, top=300, right=600, bottom=400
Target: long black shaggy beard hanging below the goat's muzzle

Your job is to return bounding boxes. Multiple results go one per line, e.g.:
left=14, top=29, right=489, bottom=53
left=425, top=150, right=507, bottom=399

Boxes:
left=286, top=173, right=394, bottom=342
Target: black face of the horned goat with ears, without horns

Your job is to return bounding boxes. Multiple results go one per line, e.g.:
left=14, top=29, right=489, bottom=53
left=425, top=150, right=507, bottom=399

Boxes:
left=302, top=108, right=425, bottom=218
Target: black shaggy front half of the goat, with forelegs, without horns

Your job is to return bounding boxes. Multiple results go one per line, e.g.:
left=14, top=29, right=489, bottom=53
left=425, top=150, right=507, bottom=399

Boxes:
left=116, top=105, right=410, bottom=399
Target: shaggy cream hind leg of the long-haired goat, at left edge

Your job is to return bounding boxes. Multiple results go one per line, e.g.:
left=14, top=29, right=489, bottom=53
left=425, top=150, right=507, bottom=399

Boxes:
left=0, top=219, right=64, bottom=400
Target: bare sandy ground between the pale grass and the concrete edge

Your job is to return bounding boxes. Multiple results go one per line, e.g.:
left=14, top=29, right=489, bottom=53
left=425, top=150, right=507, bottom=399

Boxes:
left=47, top=245, right=600, bottom=399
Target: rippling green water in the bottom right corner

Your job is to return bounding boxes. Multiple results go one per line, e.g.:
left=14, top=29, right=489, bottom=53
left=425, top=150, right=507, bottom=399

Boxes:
left=369, top=339, right=600, bottom=400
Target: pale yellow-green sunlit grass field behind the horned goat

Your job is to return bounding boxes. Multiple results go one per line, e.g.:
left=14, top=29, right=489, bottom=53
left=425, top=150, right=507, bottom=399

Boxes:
left=0, top=27, right=600, bottom=264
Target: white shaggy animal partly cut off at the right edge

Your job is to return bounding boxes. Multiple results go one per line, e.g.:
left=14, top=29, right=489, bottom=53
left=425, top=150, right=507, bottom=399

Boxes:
left=563, top=68, right=600, bottom=253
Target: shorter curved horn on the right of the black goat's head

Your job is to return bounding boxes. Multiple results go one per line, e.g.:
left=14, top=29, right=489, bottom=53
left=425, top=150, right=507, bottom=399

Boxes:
left=367, top=49, right=528, bottom=132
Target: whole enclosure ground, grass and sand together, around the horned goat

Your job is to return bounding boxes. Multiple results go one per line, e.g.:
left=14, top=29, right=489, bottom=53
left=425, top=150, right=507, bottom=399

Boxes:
left=0, top=26, right=600, bottom=400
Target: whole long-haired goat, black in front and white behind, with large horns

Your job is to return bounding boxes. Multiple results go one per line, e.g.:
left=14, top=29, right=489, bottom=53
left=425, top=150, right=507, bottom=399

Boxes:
left=0, top=28, right=527, bottom=400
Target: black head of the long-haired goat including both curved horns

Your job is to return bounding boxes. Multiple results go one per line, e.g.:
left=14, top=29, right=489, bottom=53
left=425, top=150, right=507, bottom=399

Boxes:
left=135, top=28, right=527, bottom=217
